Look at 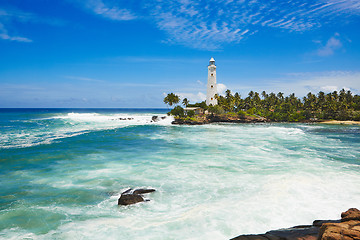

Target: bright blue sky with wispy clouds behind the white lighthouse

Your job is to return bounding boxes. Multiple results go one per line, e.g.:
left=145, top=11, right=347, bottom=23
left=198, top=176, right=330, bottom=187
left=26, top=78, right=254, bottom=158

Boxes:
left=0, top=0, right=360, bottom=108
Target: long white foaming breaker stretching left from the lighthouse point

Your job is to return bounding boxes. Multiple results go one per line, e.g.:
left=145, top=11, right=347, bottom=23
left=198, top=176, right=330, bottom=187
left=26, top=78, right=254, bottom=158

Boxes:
left=0, top=113, right=174, bottom=149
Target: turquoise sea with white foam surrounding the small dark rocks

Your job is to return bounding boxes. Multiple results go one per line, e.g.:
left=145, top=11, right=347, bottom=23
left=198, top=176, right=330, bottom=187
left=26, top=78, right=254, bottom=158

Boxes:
left=0, top=109, right=360, bottom=239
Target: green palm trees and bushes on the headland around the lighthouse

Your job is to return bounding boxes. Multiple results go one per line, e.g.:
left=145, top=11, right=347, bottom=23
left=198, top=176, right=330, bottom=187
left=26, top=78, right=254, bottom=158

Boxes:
left=164, top=89, right=360, bottom=122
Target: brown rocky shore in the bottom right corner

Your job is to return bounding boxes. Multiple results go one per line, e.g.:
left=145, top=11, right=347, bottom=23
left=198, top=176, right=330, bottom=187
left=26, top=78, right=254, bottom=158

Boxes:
left=231, top=208, right=360, bottom=240
